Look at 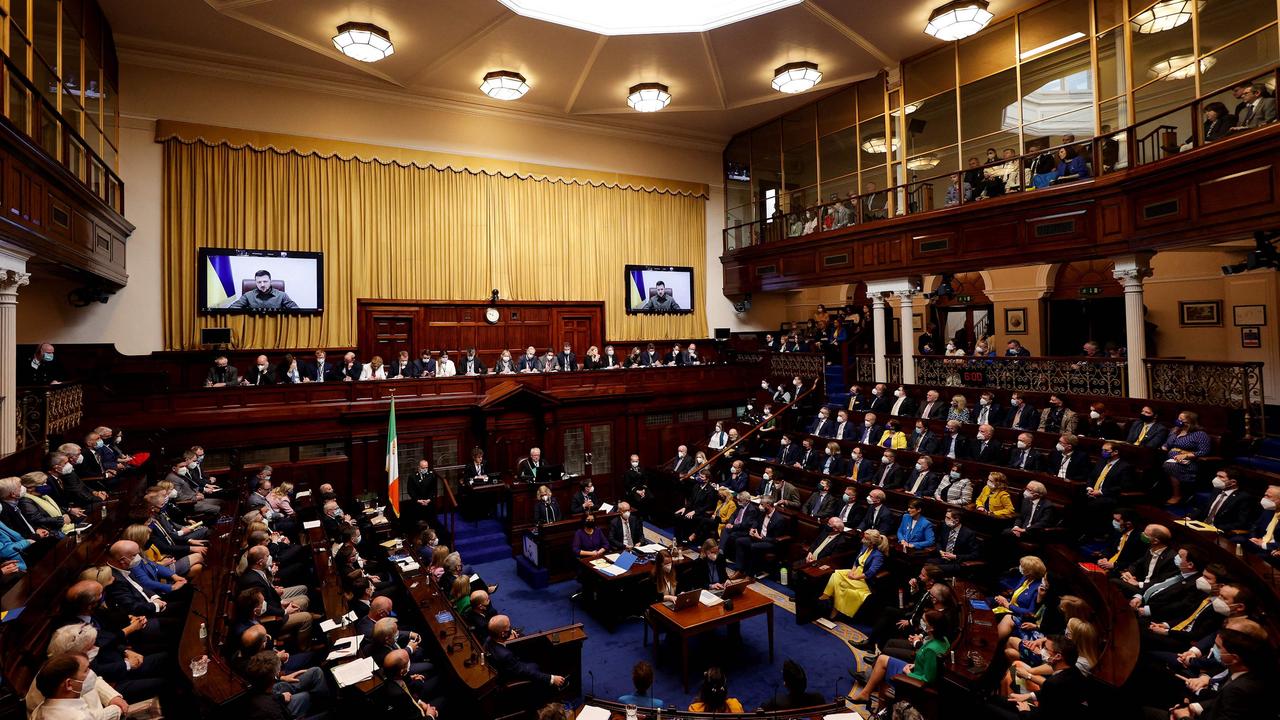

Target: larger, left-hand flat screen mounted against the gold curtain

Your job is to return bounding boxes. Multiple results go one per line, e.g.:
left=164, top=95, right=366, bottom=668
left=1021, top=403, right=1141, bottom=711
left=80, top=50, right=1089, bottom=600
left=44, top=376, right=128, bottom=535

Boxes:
left=197, top=247, right=324, bottom=314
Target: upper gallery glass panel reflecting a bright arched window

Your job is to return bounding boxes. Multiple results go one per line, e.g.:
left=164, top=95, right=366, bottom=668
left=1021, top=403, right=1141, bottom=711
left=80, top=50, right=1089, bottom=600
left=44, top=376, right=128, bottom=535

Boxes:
left=1023, top=42, right=1093, bottom=136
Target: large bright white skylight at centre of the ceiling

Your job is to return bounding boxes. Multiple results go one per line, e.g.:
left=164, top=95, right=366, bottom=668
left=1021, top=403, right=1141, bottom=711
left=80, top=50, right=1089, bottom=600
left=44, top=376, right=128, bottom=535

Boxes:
left=498, top=0, right=804, bottom=35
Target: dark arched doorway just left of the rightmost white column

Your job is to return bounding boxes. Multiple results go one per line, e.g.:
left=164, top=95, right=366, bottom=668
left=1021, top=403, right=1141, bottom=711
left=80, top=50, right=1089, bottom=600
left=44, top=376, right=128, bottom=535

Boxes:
left=1044, top=260, right=1125, bottom=355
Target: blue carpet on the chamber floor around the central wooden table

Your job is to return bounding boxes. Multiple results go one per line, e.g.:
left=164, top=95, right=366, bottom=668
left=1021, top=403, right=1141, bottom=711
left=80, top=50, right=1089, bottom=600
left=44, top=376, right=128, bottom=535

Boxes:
left=471, top=540, right=854, bottom=710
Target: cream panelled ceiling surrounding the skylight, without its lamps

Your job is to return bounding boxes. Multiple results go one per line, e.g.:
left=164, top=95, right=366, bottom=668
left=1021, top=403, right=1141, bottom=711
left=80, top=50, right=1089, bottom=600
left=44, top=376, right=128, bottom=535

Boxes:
left=101, top=0, right=1033, bottom=141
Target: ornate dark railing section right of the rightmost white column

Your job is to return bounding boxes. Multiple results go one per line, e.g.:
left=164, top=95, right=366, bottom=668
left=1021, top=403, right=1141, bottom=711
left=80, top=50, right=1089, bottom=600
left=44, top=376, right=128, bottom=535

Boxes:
left=1146, top=357, right=1266, bottom=436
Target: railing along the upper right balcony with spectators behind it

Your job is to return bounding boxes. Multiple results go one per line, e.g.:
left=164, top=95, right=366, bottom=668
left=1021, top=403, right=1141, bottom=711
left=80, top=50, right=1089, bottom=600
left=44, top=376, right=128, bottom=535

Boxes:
left=723, top=67, right=1280, bottom=254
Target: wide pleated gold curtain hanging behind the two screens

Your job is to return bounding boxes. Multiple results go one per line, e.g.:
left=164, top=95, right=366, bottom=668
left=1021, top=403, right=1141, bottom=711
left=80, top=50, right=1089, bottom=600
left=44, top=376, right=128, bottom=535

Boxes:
left=163, top=138, right=707, bottom=350
